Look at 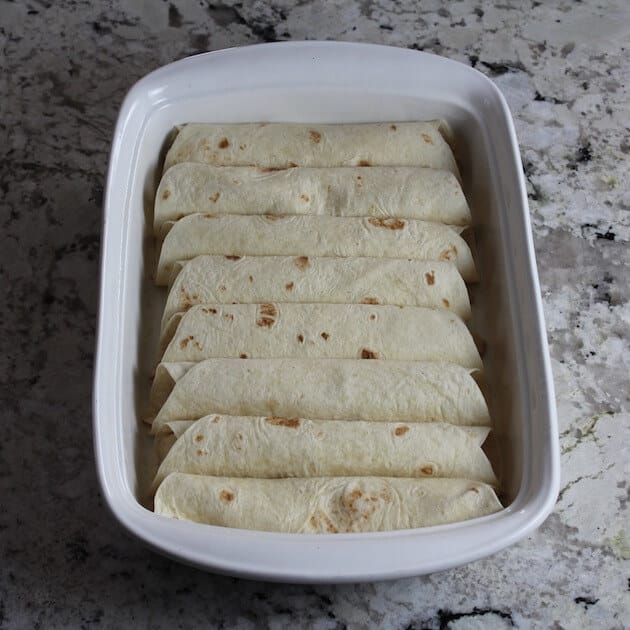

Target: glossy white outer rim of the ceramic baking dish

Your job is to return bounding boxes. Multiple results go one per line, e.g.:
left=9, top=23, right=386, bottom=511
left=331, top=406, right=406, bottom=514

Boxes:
left=93, top=41, right=560, bottom=583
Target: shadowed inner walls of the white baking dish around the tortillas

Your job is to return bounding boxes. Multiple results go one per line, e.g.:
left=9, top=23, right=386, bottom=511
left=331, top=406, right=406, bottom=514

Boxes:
left=117, top=87, right=527, bottom=507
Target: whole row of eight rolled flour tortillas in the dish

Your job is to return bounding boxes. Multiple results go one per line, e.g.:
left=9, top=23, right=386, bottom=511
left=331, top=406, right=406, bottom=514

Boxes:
left=152, top=122, right=501, bottom=532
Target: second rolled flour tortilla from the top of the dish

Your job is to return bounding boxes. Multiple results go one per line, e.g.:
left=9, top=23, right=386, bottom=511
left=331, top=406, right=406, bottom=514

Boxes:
left=154, top=162, right=471, bottom=234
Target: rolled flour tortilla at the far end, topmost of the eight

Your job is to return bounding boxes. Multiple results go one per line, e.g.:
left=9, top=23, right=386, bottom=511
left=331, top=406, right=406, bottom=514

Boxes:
left=164, top=120, right=459, bottom=175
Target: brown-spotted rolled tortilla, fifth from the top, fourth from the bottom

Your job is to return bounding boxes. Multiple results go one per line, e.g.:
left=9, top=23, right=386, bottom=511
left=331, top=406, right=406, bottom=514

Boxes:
left=162, top=303, right=483, bottom=369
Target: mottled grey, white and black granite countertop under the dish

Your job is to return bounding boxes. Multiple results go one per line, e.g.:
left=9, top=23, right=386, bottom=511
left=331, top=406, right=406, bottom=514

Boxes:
left=0, top=0, right=630, bottom=630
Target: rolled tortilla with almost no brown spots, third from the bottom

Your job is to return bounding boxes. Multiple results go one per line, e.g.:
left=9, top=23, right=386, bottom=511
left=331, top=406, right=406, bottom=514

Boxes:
left=152, top=359, right=490, bottom=433
